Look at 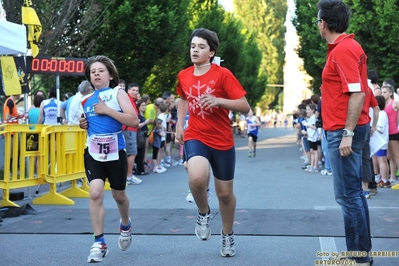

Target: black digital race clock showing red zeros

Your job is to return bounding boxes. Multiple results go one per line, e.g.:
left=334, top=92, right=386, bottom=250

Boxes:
left=27, top=56, right=87, bottom=76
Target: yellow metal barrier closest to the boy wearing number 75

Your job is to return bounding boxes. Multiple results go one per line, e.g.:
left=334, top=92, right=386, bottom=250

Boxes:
left=32, top=125, right=89, bottom=205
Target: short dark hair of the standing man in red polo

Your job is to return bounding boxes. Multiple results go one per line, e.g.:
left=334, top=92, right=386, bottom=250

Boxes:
left=317, top=0, right=351, bottom=33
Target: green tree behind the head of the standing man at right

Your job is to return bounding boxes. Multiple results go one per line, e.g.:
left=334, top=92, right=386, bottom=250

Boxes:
left=293, top=0, right=399, bottom=92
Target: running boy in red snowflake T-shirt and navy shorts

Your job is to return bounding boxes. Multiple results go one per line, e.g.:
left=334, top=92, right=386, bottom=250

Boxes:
left=176, top=28, right=250, bottom=257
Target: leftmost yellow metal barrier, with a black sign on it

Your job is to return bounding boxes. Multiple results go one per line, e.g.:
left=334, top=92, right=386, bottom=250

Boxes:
left=0, top=124, right=45, bottom=207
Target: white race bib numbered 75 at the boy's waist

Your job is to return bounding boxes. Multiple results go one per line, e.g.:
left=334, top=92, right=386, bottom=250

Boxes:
left=89, top=133, right=119, bottom=162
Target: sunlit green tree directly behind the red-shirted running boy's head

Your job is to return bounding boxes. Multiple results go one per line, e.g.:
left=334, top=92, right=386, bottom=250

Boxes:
left=187, top=0, right=266, bottom=105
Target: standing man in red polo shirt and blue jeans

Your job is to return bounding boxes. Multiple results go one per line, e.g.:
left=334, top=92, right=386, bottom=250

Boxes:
left=315, top=0, right=371, bottom=265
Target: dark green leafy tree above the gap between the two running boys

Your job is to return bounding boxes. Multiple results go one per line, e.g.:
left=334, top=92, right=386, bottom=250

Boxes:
left=92, top=0, right=185, bottom=95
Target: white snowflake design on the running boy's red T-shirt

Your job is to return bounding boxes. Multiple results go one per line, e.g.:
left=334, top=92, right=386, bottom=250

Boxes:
left=186, top=81, right=218, bottom=119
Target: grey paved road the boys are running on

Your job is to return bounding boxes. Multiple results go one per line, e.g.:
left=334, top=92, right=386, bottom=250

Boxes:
left=0, top=127, right=399, bottom=266
